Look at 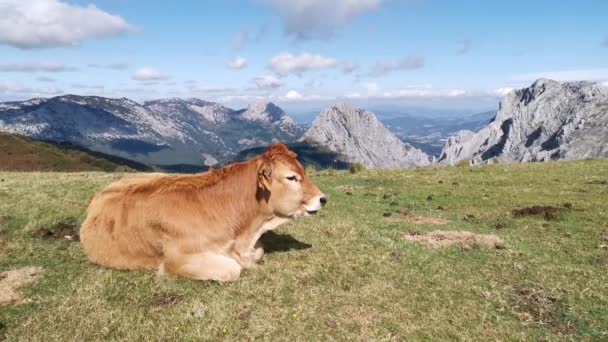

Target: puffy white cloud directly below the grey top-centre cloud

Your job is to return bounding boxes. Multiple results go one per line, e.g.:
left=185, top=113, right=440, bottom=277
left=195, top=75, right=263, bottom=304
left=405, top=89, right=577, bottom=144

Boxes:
left=270, top=52, right=337, bottom=76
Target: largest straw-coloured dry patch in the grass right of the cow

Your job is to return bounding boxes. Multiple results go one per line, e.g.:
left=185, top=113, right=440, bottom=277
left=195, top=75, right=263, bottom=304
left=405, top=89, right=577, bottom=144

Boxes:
left=403, top=230, right=505, bottom=251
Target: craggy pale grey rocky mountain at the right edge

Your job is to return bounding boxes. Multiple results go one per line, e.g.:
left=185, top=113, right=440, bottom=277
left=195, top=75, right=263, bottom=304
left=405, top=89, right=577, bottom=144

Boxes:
left=439, top=79, right=608, bottom=164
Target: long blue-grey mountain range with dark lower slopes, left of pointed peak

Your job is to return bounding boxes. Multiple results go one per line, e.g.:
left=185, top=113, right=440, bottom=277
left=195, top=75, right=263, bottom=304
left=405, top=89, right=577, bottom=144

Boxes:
left=0, top=95, right=302, bottom=169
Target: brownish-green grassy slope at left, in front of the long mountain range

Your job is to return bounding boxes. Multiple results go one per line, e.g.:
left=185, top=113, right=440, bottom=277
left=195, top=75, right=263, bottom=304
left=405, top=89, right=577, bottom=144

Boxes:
left=0, top=133, right=152, bottom=172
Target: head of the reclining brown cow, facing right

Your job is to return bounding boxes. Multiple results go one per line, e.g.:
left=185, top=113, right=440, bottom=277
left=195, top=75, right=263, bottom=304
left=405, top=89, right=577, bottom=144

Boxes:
left=258, top=144, right=327, bottom=217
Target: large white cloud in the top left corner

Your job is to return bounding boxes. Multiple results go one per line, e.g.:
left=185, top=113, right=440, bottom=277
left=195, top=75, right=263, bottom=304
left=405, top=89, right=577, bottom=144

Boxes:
left=0, top=0, right=133, bottom=49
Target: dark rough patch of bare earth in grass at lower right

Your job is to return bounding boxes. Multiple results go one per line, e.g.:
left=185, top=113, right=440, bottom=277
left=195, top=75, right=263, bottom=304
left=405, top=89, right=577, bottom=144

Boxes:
left=509, top=287, right=575, bottom=332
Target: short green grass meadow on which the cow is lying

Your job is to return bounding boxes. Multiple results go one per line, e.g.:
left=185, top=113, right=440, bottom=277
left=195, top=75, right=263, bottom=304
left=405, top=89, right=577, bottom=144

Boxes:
left=0, top=160, right=608, bottom=341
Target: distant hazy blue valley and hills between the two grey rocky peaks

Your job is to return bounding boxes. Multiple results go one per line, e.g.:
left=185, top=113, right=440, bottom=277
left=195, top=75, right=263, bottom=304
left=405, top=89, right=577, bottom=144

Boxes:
left=381, top=111, right=496, bottom=157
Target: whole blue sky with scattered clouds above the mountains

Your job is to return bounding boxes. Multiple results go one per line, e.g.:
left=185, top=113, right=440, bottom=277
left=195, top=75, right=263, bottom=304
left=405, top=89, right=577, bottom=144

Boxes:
left=0, top=0, right=608, bottom=115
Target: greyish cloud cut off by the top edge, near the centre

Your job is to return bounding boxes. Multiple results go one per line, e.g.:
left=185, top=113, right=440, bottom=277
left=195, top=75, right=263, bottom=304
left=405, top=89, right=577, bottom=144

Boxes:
left=262, top=0, right=381, bottom=39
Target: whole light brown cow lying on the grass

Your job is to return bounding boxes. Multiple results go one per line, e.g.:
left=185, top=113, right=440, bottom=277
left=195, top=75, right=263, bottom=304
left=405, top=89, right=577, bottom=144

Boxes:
left=80, top=145, right=327, bottom=281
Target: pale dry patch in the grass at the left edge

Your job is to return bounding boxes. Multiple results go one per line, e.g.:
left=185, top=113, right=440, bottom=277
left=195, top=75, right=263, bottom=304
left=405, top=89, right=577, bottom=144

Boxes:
left=0, top=267, right=44, bottom=306
